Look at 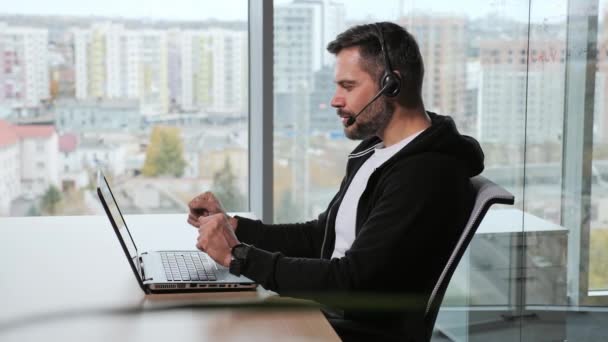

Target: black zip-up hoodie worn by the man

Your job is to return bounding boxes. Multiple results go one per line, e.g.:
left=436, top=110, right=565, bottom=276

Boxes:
left=236, top=112, right=484, bottom=340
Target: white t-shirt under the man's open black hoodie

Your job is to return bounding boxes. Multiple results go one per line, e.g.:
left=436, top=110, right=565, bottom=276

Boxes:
left=331, top=130, right=424, bottom=258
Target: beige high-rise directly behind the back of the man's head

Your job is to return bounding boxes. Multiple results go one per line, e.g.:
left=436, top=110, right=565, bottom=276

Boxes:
left=398, top=15, right=473, bottom=126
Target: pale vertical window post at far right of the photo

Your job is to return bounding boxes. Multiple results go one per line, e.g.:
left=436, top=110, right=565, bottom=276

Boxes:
left=561, top=0, right=608, bottom=306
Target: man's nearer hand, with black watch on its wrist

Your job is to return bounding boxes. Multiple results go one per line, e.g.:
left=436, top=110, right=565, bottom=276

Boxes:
left=196, top=213, right=239, bottom=267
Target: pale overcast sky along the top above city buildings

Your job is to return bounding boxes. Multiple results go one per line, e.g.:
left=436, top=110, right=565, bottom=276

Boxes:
left=0, top=0, right=608, bottom=21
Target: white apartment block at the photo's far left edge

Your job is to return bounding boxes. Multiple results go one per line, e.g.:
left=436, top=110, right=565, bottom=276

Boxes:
left=0, top=23, right=50, bottom=107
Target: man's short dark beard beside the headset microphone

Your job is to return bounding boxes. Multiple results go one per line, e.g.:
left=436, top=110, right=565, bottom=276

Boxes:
left=338, top=101, right=395, bottom=140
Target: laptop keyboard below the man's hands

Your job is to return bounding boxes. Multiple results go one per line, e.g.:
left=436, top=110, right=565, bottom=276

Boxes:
left=160, top=252, right=217, bottom=281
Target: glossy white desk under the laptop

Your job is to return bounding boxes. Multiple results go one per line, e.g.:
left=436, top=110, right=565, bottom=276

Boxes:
left=0, top=214, right=339, bottom=342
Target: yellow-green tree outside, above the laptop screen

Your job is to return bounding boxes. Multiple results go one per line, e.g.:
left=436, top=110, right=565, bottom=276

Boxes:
left=142, top=126, right=186, bottom=177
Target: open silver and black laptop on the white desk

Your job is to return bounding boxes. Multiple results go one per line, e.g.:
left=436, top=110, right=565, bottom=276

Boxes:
left=97, top=171, right=257, bottom=293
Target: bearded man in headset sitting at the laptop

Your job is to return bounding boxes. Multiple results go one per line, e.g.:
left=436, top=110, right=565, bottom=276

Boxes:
left=188, top=22, right=483, bottom=340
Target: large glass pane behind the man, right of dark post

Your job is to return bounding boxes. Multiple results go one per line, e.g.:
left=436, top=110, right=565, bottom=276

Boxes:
left=274, top=0, right=608, bottom=341
